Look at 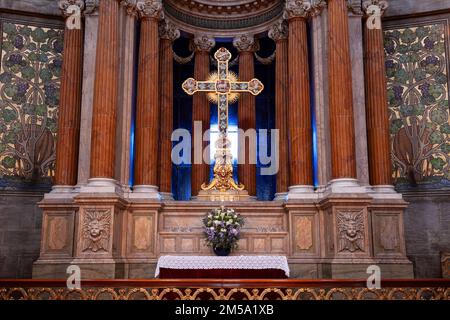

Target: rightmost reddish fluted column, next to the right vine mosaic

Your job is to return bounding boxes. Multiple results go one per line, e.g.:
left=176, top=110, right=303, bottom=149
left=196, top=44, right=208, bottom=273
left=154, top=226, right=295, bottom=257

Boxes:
left=363, top=0, right=392, bottom=186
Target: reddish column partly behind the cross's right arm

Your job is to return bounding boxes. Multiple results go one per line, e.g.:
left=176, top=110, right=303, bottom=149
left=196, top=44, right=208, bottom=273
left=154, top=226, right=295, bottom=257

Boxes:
left=233, top=35, right=258, bottom=196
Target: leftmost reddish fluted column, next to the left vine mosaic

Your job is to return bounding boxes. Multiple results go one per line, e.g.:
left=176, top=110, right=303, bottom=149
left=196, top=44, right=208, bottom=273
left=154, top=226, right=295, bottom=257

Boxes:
left=54, top=0, right=84, bottom=189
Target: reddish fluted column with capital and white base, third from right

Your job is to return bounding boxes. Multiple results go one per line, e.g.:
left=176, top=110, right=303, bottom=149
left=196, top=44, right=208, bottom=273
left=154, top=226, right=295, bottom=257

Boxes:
left=285, top=1, right=314, bottom=199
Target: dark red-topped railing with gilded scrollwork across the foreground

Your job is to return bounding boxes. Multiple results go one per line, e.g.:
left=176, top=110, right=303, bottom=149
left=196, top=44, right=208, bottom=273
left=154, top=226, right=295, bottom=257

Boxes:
left=0, top=279, right=450, bottom=300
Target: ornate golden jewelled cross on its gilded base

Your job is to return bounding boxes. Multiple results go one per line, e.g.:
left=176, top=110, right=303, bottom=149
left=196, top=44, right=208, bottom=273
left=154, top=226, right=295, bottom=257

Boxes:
left=183, top=48, right=264, bottom=192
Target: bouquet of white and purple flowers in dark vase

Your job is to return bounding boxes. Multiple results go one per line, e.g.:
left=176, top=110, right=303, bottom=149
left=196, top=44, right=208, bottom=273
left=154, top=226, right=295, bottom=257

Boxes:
left=203, top=207, right=244, bottom=256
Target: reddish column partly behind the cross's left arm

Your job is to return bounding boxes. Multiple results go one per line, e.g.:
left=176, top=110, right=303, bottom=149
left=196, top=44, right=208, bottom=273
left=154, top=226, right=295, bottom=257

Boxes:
left=191, top=35, right=215, bottom=196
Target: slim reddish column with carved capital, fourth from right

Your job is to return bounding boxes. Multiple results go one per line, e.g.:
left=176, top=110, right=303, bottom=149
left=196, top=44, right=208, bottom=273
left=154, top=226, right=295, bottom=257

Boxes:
left=269, top=20, right=289, bottom=200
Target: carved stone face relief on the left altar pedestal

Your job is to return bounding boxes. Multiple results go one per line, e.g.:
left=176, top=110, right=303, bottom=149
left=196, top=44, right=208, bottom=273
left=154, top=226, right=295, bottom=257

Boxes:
left=82, top=209, right=112, bottom=252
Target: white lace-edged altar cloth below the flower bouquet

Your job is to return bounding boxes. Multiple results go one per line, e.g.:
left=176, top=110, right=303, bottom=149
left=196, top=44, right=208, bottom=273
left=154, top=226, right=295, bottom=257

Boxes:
left=155, top=256, right=289, bottom=277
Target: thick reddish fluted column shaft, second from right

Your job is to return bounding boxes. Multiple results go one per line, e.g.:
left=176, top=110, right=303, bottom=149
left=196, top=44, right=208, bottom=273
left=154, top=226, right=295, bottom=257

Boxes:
left=328, top=0, right=356, bottom=181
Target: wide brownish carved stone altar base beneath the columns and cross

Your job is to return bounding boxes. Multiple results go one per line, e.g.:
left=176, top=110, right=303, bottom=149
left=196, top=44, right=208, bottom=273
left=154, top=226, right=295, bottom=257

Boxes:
left=33, top=195, right=413, bottom=278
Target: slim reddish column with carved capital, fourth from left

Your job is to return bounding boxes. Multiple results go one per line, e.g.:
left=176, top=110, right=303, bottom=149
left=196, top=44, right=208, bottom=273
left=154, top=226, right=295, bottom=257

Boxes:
left=159, top=21, right=180, bottom=200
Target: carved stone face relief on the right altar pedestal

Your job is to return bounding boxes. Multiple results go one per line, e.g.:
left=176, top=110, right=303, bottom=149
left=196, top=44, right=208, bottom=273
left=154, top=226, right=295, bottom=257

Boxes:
left=337, top=210, right=364, bottom=253
